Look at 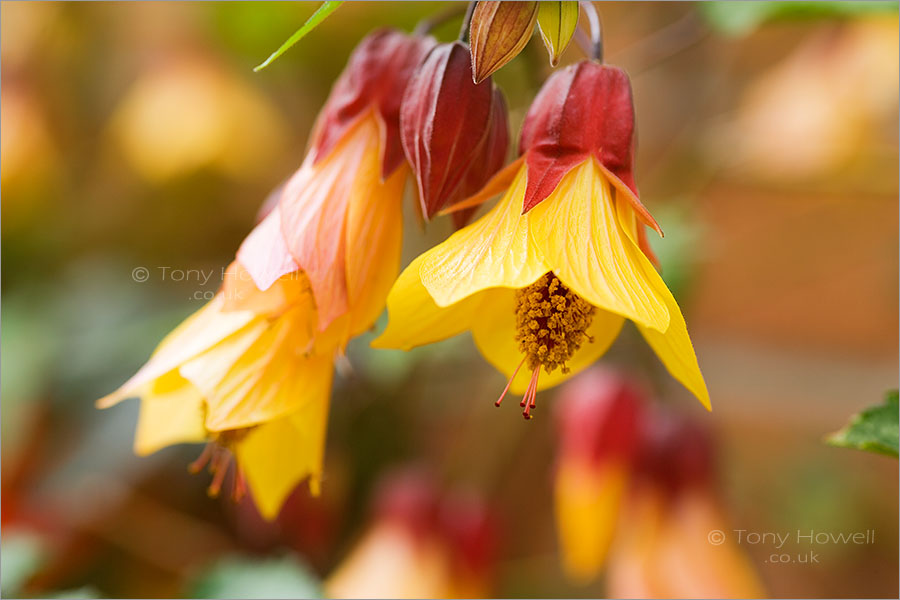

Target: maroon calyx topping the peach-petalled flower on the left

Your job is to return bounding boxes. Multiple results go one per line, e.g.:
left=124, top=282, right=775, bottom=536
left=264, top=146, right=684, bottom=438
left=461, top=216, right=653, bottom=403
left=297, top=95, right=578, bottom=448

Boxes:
left=312, top=29, right=435, bottom=178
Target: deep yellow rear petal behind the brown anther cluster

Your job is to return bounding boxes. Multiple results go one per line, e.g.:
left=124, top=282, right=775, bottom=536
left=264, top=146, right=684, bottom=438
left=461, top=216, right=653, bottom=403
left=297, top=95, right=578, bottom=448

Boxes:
left=472, top=289, right=624, bottom=394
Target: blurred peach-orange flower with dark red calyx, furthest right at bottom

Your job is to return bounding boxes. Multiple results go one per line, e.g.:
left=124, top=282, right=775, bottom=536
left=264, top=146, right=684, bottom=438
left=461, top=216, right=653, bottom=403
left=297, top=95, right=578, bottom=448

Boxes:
left=606, top=411, right=765, bottom=598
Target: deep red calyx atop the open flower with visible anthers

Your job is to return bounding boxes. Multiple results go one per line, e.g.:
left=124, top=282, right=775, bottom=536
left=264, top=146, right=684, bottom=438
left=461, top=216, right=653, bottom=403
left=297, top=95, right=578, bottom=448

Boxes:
left=519, top=61, right=658, bottom=230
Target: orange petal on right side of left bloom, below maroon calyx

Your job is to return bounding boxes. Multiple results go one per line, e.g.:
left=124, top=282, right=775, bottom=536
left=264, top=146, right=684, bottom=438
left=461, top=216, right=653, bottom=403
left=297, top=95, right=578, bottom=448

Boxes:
left=346, top=166, right=408, bottom=336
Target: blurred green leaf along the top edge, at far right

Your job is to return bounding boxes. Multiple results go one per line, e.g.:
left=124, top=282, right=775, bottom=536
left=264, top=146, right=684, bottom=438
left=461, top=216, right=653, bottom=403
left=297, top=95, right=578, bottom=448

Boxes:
left=699, top=0, right=898, bottom=36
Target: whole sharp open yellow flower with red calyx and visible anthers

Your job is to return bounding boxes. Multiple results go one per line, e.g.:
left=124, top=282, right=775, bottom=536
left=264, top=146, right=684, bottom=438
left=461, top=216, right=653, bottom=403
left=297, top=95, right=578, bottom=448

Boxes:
left=373, top=61, right=709, bottom=418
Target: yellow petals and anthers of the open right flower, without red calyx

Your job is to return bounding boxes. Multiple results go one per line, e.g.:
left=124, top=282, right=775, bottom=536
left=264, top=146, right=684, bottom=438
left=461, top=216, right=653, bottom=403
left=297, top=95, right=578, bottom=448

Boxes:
left=373, top=157, right=709, bottom=418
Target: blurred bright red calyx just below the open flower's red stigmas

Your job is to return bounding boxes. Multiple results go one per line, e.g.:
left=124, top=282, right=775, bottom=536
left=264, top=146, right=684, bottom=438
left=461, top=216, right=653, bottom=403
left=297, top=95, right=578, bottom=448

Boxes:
left=557, top=368, right=645, bottom=464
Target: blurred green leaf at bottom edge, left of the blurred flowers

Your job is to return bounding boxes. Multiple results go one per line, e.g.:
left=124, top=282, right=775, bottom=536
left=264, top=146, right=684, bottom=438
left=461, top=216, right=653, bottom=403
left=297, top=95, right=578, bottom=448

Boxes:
left=189, top=555, right=321, bottom=598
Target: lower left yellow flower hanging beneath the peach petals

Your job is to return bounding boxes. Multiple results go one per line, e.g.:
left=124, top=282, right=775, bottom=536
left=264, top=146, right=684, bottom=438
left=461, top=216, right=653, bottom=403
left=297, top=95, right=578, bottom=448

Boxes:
left=97, top=263, right=334, bottom=519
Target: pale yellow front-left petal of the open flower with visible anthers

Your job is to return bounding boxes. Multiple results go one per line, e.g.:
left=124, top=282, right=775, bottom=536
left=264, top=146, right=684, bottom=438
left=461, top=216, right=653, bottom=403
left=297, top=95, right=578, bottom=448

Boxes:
left=419, top=164, right=550, bottom=306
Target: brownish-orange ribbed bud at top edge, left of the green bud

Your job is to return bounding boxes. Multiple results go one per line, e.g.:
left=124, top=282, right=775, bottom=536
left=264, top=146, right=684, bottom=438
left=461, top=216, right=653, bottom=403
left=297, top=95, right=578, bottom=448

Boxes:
left=469, top=1, right=538, bottom=83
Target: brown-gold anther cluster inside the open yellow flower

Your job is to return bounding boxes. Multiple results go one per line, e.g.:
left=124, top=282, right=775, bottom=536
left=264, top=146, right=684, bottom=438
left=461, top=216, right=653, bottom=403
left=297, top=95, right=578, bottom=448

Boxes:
left=516, top=273, right=597, bottom=373
